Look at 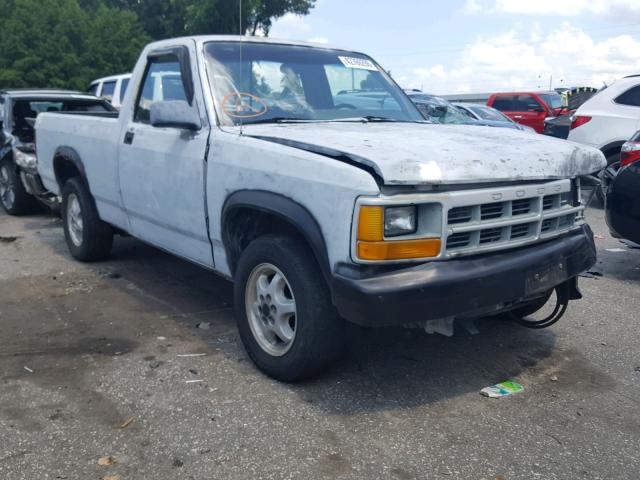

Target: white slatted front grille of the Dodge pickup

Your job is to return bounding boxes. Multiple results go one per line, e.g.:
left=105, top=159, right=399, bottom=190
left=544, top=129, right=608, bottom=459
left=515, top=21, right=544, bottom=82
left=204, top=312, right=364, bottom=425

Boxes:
left=444, top=181, right=584, bottom=256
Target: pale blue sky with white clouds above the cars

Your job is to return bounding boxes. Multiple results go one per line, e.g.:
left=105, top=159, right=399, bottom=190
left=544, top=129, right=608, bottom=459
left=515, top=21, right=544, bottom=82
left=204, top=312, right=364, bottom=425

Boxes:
left=270, top=0, right=640, bottom=95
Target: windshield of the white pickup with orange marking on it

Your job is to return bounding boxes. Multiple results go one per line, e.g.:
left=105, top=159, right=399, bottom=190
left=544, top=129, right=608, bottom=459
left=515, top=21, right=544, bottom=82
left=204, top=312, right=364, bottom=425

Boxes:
left=205, top=42, right=423, bottom=125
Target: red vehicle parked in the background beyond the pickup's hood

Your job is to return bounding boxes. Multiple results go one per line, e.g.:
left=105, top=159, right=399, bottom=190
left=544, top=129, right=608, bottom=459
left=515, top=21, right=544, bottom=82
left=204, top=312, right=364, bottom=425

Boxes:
left=487, top=91, right=568, bottom=133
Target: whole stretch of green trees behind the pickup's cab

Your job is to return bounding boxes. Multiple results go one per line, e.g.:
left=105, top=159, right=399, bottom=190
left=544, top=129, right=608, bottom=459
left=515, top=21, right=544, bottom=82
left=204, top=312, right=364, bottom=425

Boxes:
left=0, top=0, right=316, bottom=90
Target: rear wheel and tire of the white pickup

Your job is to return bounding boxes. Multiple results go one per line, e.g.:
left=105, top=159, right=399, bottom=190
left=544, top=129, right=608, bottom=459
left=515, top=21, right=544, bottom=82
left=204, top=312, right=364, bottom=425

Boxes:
left=62, top=177, right=113, bottom=262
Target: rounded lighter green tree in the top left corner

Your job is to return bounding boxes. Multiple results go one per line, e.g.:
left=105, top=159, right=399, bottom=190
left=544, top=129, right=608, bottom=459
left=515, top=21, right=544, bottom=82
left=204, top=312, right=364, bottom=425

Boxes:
left=0, top=0, right=148, bottom=90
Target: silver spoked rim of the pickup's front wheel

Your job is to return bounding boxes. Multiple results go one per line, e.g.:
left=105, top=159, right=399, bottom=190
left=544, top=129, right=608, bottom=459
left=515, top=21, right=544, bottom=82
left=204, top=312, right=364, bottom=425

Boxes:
left=245, top=263, right=297, bottom=357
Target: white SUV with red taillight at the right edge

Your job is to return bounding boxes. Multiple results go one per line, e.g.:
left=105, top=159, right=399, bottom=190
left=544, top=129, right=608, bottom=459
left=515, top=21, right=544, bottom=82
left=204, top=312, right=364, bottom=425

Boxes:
left=569, top=75, right=640, bottom=164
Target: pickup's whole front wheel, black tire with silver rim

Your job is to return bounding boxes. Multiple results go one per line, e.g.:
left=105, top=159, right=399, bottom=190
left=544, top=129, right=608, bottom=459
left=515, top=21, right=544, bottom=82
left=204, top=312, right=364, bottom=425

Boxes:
left=234, top=235, right=345, bottom=382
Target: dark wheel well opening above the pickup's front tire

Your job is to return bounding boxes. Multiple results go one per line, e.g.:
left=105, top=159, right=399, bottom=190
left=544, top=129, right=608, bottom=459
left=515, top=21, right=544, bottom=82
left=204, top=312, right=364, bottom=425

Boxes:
left=222, top=207, right=310, bottom=274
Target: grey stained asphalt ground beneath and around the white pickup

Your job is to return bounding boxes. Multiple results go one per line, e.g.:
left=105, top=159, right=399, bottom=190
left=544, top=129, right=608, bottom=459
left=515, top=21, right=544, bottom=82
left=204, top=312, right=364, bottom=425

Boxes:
left=0, top=204, right=640, bottom=480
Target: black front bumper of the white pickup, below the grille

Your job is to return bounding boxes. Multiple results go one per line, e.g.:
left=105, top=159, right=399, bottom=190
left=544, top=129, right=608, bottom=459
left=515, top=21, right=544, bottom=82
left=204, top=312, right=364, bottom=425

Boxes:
left=332, top=225, right=596, bottom=327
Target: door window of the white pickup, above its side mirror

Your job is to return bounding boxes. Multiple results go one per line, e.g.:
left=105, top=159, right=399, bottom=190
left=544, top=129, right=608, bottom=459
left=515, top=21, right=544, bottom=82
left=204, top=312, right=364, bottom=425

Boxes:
left=134, top=55, right=187, bottom=123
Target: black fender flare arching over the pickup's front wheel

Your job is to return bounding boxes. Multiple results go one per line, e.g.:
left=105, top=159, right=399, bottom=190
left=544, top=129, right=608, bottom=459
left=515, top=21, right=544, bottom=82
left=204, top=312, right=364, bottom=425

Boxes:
left=221, top=190, right=331, bottom=288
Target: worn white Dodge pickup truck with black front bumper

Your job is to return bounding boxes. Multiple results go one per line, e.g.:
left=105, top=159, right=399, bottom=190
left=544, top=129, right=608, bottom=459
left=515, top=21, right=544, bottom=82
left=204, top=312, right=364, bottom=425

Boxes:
left=36, top=36, right=605, bottom=381
